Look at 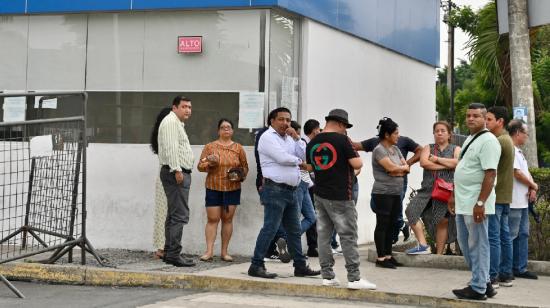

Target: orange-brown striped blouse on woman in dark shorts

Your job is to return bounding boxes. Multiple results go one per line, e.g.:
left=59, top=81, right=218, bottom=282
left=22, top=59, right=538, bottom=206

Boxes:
left=198, top=141, right=248, bottom=191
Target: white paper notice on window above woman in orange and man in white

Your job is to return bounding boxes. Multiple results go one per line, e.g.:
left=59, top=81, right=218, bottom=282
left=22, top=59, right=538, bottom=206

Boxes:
left=239, top=91, right=265, bottom=129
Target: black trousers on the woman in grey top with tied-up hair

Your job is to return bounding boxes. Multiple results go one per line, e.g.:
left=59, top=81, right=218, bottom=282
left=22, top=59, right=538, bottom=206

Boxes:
left=372, top=194, right=401, bottom=258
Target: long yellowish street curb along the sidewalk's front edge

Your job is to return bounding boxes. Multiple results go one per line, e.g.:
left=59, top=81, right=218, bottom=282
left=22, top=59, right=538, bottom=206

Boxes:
left=0, top=263, right=536, bottom=308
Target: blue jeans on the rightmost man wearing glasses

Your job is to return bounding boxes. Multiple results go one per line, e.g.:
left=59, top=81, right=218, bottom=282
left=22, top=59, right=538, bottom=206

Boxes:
left=508, top=208, right=529, bottom=274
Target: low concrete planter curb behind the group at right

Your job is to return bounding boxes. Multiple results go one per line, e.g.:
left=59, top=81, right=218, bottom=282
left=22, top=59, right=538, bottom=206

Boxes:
left=367, top=248, right=550, bottom=276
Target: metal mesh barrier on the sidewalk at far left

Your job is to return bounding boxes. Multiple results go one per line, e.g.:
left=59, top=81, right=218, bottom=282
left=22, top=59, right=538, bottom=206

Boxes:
left=0, top=92, right=103, bottom=297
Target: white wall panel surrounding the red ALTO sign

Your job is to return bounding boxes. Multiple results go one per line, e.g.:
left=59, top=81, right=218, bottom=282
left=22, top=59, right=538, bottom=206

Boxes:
left=144, top=10, right=260, bottom=91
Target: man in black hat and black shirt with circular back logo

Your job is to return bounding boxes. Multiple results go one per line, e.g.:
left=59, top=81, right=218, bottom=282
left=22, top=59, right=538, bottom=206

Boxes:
left=306, top=109, right=376, bottom=289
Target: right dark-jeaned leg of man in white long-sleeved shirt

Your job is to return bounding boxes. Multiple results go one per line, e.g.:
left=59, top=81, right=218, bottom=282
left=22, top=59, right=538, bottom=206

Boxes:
left=281, top=190, right=306, bottom=267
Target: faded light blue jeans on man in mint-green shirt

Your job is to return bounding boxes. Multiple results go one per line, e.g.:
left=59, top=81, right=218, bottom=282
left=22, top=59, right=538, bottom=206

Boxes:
left=456, top=214, right=490, bottom=294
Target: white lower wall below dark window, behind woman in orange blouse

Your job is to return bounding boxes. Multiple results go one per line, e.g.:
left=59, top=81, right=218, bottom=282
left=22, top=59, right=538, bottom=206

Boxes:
left=87, top=143, right=263, bottom=255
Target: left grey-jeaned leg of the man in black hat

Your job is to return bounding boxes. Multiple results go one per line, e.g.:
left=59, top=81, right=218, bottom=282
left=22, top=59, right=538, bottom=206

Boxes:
left=314, top=196, right=336, bottom=279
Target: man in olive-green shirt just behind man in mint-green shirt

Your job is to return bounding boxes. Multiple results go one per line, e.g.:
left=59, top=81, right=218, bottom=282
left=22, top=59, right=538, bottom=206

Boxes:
left=487, top=106, right=515, bottom=288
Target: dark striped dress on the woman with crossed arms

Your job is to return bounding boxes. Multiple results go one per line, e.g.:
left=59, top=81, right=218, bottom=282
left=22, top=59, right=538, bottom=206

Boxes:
left=405, top=144, right=456, bottom=243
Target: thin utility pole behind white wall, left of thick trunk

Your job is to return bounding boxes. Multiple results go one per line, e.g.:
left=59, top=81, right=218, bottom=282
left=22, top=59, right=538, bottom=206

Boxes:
left=441, top=0, right=455, bottom=129
